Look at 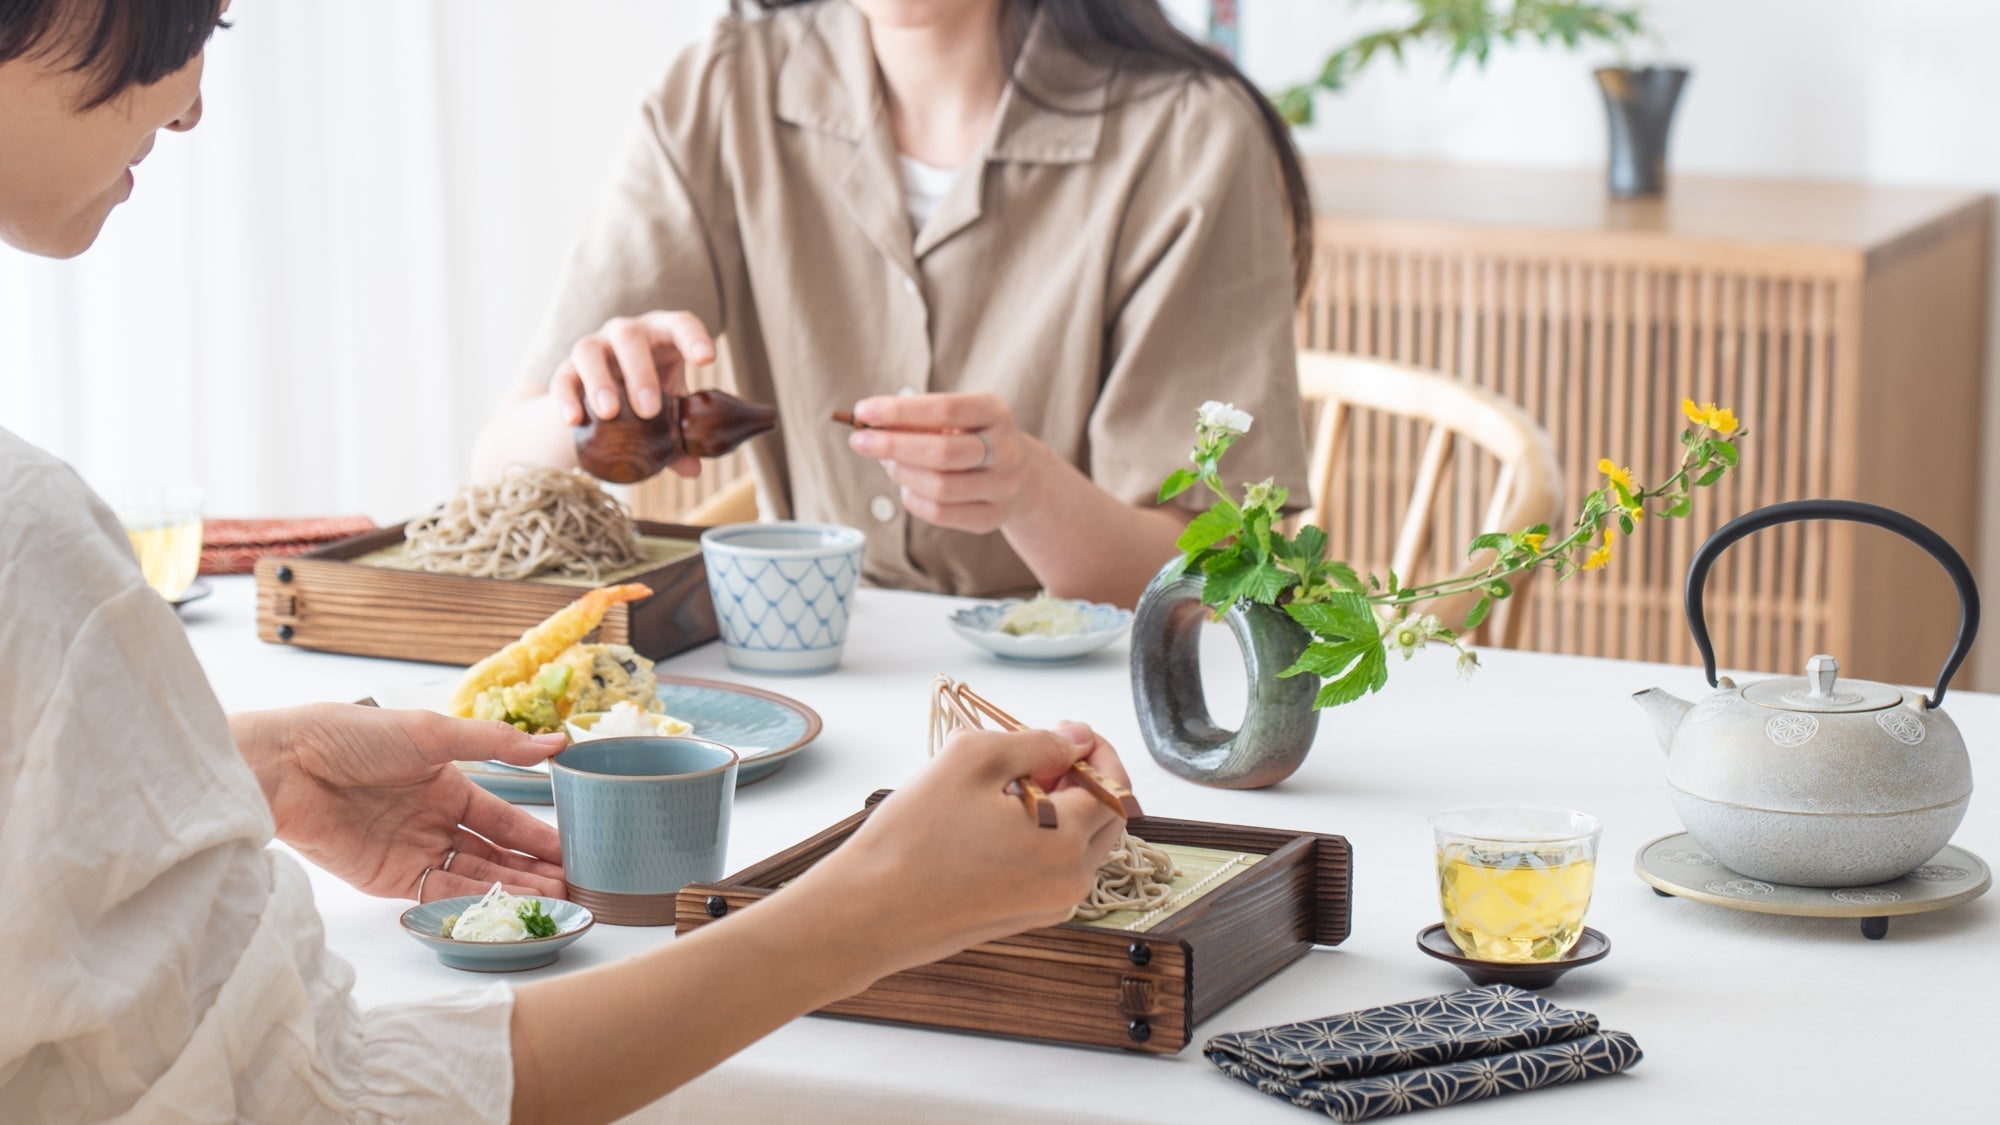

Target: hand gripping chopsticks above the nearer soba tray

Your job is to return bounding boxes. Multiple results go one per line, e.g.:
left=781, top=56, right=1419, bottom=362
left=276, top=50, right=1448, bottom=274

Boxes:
left=798, top=723, right=1126, bottom=971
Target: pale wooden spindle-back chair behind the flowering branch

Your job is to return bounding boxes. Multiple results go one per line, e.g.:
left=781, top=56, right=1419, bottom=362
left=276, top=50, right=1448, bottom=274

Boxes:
left=1298, top=350, right=1562, bottom=647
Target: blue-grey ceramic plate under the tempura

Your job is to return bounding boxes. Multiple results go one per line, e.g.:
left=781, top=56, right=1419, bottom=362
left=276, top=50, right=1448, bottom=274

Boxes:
left=374, top=677, right=820, bottom=805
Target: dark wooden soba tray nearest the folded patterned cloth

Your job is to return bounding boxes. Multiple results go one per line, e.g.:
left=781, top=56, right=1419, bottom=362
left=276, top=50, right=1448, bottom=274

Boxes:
left=674, top=791, right=1352, bottom=1055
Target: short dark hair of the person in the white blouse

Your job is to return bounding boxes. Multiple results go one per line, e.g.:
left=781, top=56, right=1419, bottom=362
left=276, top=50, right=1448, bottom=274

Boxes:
left=0, top=0, right=222, bottom=110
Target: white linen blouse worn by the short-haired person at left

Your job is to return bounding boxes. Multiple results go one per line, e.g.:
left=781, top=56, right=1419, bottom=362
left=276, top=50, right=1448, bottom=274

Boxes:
left=0, top=432, right=514, bottom=1125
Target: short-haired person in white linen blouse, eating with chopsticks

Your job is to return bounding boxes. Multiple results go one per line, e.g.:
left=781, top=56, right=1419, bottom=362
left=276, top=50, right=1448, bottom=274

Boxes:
left=0, top=0, right=1124, bottom=1123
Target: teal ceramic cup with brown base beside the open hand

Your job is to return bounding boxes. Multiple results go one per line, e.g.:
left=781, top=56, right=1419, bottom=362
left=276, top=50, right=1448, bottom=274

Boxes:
left=548, top=739, right=736, bottom=925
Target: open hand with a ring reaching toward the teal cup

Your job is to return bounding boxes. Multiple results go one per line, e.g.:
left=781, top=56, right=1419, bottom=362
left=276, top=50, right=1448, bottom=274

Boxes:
left=230, top=703, right=568, bottom=901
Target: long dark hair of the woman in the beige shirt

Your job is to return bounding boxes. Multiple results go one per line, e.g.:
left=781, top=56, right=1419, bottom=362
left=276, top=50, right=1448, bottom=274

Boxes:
left=736, top=0, right=1312, bottom=294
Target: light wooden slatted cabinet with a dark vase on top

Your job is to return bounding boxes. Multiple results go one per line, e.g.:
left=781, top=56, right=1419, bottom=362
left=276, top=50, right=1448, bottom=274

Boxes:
left=1300, top=158, right=1992, bottom=685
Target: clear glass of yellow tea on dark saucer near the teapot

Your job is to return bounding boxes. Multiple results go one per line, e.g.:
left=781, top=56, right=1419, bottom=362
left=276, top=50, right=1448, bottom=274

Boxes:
left=1430, top=805, right=1602, bottom=963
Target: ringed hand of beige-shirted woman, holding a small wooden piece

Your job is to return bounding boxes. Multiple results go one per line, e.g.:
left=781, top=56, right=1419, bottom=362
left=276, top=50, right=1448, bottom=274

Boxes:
left=848, top=394, right=1050, bottom=532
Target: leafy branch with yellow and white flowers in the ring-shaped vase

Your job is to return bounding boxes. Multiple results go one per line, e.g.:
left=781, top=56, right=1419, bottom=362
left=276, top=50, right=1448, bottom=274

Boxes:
left=1160, top=398, right=1746, bottom=707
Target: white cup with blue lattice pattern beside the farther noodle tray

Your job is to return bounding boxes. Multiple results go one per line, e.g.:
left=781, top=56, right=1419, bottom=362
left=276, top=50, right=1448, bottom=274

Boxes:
left=702, top=522, right=864, bottom=675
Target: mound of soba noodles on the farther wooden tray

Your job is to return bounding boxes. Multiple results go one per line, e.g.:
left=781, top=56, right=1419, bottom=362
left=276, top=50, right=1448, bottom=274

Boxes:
left=404, top=464, right=640, bottom=583
